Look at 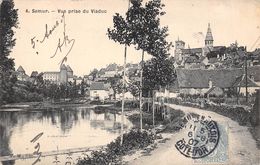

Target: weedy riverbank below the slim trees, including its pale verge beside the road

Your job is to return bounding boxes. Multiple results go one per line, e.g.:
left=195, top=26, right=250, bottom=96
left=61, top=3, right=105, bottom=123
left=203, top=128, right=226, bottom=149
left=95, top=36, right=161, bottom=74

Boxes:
left=74, top=106, right=184, bottom=165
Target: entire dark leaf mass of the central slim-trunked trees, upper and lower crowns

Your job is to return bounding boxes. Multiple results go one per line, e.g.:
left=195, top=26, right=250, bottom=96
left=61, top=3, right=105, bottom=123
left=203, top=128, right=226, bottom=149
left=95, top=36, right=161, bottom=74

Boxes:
left=108, top=0, right=175, bottom=96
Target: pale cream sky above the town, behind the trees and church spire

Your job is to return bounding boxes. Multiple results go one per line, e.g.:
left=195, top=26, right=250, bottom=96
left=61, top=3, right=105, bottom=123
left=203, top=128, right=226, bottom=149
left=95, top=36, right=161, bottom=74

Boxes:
left=11, top=0, right=260, bottom=76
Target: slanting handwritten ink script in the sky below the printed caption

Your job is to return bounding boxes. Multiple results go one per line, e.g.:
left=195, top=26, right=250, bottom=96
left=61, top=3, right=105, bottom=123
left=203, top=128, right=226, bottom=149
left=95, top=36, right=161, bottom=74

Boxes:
left=31, top=13, right=75, bottom=64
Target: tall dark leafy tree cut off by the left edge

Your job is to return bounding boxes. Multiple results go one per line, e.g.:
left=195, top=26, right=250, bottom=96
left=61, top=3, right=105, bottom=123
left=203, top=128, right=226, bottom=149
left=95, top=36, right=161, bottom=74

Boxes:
left=0, top=0, right=18, bottom=104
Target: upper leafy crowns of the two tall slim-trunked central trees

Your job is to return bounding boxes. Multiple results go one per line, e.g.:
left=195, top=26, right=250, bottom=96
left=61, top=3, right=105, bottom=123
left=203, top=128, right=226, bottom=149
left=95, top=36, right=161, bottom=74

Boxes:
left=108, top=0, right=171, bottom=57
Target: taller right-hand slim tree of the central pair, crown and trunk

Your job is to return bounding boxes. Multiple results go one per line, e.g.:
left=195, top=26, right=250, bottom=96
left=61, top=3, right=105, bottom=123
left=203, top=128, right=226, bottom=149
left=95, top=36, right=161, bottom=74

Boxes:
left=127, top=0, right=171, bottom=130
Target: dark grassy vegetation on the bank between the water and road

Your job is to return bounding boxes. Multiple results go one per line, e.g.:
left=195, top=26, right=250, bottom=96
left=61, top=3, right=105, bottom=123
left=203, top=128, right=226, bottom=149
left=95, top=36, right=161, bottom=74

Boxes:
left=77, top=104, right=184, bottom=165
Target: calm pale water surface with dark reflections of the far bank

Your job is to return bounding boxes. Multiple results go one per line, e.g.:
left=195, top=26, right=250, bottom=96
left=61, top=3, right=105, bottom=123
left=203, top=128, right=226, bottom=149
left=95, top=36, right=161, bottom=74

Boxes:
left=0, top=108, right=131, bottom=164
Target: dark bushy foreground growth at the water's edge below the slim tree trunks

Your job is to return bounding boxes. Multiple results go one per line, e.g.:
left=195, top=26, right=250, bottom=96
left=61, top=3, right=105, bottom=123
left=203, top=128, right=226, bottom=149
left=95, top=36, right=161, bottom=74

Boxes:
left=77, top=129, right=154, bottom=165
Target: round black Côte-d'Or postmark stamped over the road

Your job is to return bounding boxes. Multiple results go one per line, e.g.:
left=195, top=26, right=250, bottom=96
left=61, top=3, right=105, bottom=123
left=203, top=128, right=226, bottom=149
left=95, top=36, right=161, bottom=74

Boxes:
left=175, top=114, right=220, bottom=159
